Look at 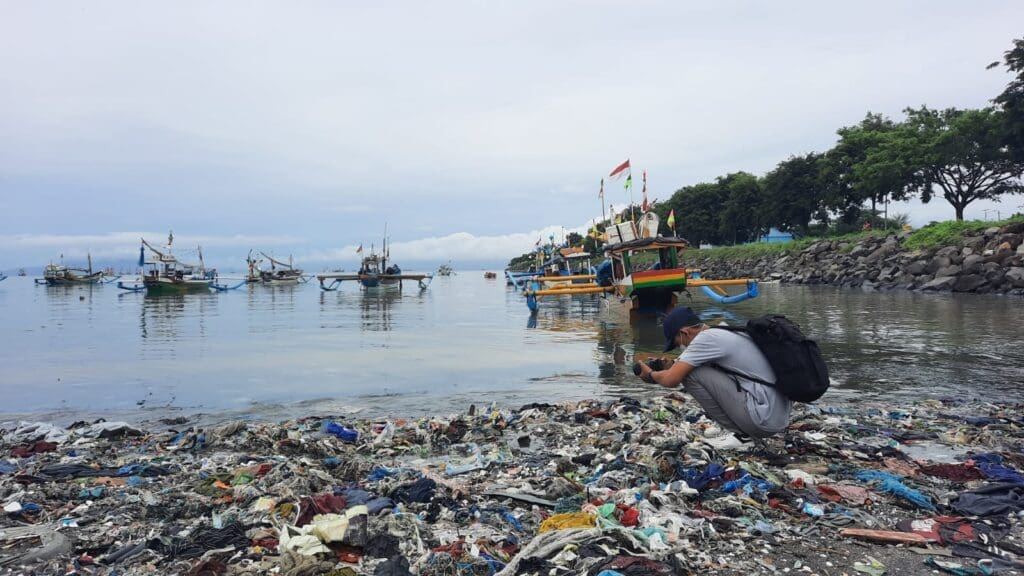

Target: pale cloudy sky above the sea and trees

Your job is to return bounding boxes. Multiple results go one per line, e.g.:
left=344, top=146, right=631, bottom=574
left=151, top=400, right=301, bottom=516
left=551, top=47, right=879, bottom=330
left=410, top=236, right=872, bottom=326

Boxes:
left=0, top=0, right=1024, bottom=271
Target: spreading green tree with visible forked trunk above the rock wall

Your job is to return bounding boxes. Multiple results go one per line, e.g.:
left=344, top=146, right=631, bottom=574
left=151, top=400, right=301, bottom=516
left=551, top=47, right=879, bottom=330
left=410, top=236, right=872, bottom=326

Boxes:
left=894, top=107, right=1024, bottom=220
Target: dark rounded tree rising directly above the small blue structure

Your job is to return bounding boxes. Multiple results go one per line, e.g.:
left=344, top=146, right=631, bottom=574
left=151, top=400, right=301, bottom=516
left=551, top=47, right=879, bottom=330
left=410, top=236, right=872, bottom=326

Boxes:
left=761, top=153, right=828, bottom=234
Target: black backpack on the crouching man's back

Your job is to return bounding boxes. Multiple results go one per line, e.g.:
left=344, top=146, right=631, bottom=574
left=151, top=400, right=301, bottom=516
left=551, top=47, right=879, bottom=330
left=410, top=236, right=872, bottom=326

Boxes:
left=713, top=314, right=828, bottom=402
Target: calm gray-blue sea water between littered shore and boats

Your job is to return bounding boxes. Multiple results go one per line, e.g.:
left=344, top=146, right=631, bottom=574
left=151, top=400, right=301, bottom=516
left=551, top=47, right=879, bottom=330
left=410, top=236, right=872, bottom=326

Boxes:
left=0, top=271, right=1024, bottom=422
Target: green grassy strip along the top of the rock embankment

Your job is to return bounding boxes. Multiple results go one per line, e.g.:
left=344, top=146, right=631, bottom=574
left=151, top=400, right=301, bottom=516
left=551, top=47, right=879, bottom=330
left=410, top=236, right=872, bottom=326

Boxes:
left=685, top=216, right=1024, bottom=260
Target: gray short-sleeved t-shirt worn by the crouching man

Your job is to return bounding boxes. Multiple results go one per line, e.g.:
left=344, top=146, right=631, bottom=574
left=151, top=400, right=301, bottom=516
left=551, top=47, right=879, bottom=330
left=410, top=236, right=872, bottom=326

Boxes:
left=679, top=328, right=793, bottom=421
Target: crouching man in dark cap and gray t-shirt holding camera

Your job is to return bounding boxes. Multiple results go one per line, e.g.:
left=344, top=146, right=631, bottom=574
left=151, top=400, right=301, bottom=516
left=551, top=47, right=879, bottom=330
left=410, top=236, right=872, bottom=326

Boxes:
left=639, top=306, right=793, bottom=439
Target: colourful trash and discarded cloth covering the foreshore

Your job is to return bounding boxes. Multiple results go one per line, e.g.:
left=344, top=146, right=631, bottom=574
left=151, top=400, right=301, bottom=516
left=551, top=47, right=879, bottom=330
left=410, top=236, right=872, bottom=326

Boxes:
left=0, top=393, right=1024, bottom=576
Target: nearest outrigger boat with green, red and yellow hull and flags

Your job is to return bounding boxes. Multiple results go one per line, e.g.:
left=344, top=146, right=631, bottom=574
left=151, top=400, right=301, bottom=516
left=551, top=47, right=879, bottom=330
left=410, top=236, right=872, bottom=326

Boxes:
left=524, top=213, right=759, bottom=316
